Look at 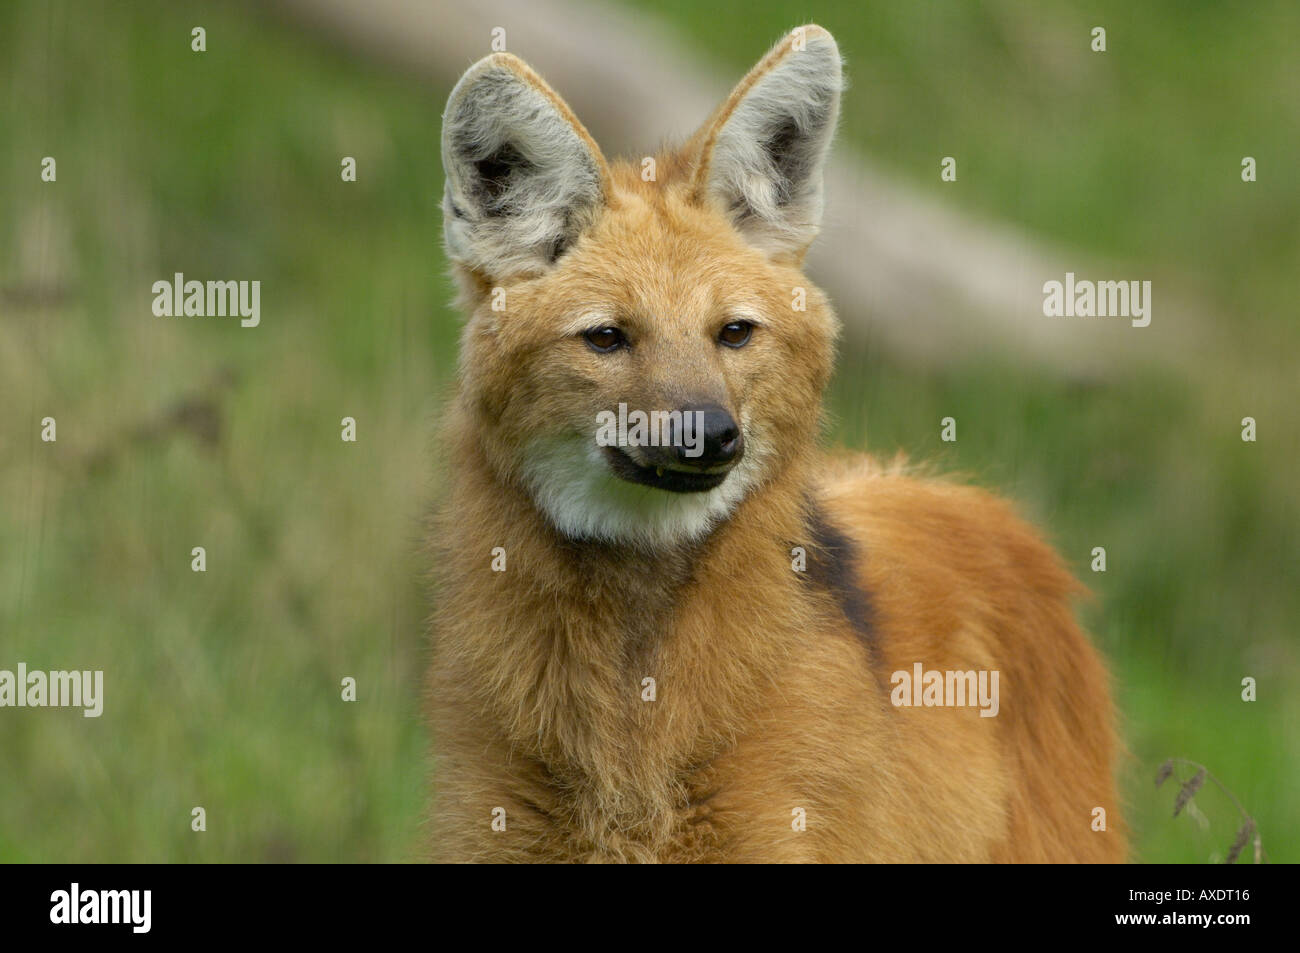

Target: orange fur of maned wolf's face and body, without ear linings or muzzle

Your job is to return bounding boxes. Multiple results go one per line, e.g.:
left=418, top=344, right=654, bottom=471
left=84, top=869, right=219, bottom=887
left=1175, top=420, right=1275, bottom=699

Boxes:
left=429, top=27, right=1125, bottom=862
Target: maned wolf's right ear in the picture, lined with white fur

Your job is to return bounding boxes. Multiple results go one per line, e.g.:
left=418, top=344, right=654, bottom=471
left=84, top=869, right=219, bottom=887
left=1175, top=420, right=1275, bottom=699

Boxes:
left=693, top=25, right=844, bottom=259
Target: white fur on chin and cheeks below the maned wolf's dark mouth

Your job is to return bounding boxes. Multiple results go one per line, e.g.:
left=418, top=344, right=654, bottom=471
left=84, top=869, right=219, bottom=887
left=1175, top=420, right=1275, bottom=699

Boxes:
left=524, top=433, right=763, bottom=549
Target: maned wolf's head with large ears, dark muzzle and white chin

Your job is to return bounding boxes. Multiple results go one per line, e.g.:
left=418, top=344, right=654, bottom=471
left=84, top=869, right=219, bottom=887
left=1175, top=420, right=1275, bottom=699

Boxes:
left=442, top=26, right=841, bottom=549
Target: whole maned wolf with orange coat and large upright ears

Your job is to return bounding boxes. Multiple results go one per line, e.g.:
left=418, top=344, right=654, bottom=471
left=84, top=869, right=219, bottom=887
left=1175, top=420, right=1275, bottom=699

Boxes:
left=429, top=26, right=1125, bottom=862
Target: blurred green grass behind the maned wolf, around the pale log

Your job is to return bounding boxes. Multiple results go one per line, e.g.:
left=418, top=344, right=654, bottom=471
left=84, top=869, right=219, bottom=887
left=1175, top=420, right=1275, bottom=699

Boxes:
left=0, top=0, right=1300, bottom=862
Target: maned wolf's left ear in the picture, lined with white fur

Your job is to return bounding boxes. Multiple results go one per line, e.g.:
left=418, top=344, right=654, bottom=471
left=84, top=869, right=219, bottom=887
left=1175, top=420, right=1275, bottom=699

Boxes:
left=442, top=53, right=608, bottom=280
